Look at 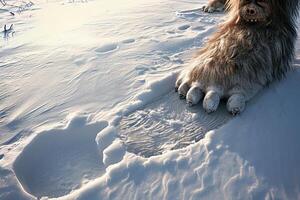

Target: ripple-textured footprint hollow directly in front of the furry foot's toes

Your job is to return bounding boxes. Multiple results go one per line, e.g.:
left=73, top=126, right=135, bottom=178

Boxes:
left=119, top=92, right=231, bottom=157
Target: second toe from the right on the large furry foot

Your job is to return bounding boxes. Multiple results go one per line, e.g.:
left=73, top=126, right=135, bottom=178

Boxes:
left=203, top=90, right=220, bottom=113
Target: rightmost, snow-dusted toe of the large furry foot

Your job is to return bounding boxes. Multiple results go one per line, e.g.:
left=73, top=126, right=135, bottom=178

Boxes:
left=227, top=94, right=246, bottom=116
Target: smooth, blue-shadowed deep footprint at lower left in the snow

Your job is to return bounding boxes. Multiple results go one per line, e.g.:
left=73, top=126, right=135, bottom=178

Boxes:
left=13, top=118, right=107, bottom=198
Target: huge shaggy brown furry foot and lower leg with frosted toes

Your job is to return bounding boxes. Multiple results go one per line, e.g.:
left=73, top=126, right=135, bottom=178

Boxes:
left=176, top=0, right=299, bottom=114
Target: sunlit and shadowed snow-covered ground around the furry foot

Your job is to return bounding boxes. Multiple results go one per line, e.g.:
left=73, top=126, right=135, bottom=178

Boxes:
left=0, top=0, right=300, bottom=200
